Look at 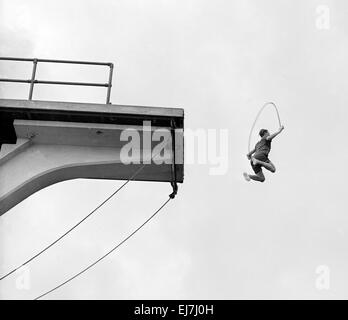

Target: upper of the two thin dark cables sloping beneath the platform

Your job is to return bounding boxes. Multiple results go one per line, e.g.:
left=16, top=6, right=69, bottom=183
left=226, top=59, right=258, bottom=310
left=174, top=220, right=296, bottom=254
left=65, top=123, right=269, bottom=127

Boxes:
left=0, top=163, right=150, bottom=281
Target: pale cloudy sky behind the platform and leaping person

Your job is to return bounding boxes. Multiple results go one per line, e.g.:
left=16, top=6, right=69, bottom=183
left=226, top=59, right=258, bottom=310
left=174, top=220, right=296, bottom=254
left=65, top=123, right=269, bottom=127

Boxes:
left=0, top=0, right=348, bottom=299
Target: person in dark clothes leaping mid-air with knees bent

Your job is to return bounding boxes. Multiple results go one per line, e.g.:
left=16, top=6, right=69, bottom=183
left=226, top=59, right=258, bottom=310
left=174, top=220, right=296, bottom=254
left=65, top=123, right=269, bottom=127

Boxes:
left=243, top=126, right=284, bottom=182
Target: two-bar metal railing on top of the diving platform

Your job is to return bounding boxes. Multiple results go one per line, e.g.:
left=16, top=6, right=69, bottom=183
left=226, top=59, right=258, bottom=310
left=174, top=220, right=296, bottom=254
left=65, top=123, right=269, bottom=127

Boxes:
left=0, top=57, right=114, bottom=104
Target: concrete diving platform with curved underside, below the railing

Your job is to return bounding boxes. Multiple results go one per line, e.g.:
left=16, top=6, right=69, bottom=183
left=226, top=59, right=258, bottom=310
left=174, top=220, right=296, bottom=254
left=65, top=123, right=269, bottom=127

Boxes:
left=0, top=99, right=184, bottom=215
